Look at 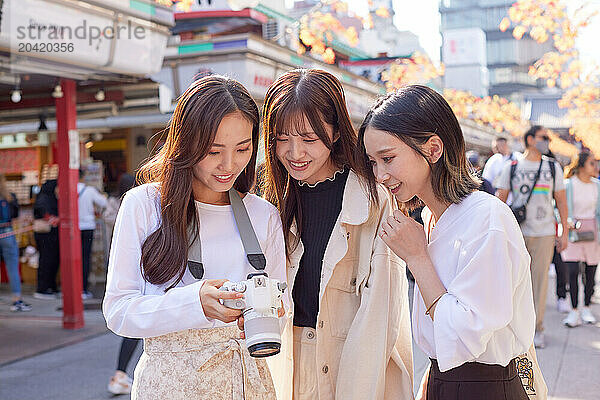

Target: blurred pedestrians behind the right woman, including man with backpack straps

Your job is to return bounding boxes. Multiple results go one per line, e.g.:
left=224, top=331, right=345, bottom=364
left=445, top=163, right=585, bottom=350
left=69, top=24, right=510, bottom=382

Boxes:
left=467, top=126, right=600, bottom=348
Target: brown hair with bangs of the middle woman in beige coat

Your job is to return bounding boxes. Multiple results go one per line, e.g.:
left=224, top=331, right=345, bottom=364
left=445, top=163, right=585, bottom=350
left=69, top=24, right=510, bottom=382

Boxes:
left=262, top=69, right=377, bottom=254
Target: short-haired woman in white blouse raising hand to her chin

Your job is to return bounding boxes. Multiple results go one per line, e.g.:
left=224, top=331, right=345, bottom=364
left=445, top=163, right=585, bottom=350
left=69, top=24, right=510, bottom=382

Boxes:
left=359, top=85, right=535, bottom=400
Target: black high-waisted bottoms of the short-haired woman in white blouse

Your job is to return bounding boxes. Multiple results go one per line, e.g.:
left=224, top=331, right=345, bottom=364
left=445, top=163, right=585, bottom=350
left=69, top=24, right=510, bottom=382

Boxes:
left=427, top=359, right=529, bottom=400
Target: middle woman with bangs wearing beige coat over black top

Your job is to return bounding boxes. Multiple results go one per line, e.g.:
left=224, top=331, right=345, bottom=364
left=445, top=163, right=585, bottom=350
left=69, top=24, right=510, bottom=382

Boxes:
left=263, top=69, right=413, bottom=400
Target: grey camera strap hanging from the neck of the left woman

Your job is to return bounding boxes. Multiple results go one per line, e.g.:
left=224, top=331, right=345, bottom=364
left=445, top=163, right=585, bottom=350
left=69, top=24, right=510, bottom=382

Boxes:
left=187, top=188, right=267, bottom=279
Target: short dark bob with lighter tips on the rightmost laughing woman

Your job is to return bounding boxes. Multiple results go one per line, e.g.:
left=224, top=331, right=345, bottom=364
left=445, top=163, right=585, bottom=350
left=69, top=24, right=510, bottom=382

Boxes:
left=357, top=85, right=481, bottom=209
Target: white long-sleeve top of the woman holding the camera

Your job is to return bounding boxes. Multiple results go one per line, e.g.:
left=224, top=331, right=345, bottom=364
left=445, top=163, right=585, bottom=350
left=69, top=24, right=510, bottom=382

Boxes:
left=103, top=185, right=289, bottom=338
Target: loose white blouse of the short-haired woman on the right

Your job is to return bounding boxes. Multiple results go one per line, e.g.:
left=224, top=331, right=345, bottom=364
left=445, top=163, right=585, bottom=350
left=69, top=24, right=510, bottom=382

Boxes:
left=412, top=191, right=535, bottom=371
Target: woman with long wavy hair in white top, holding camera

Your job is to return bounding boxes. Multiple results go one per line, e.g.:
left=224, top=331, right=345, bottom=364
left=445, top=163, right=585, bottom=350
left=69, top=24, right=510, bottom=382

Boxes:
left=103, top=76, right=285, bottom=400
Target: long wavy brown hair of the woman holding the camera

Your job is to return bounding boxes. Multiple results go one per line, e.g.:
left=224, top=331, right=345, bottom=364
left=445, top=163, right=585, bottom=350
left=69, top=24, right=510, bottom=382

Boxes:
left=138, top=75, right=259, bottom=290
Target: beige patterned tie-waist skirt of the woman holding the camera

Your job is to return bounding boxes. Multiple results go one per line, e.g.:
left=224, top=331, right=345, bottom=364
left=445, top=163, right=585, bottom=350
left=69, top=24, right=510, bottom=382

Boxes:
left=131, top=326, right=276, bottom=400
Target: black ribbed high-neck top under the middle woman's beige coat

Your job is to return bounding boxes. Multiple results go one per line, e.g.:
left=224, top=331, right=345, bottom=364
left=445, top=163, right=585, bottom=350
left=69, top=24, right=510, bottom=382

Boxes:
left=292, top=169, right=348, bottom=328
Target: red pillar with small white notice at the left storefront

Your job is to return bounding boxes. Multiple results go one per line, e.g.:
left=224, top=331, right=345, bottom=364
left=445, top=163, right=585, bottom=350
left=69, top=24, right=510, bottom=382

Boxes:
left=56, top=79, right=84, bottom=329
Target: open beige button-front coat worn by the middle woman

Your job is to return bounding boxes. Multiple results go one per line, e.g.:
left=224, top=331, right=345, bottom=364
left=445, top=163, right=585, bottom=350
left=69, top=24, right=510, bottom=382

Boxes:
left=268, top=171, right=413, bottom=400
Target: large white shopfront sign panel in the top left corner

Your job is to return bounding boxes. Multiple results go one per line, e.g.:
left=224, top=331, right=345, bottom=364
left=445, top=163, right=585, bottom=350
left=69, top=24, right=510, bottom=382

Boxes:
left=0, top=0, right=172, bottom=75
